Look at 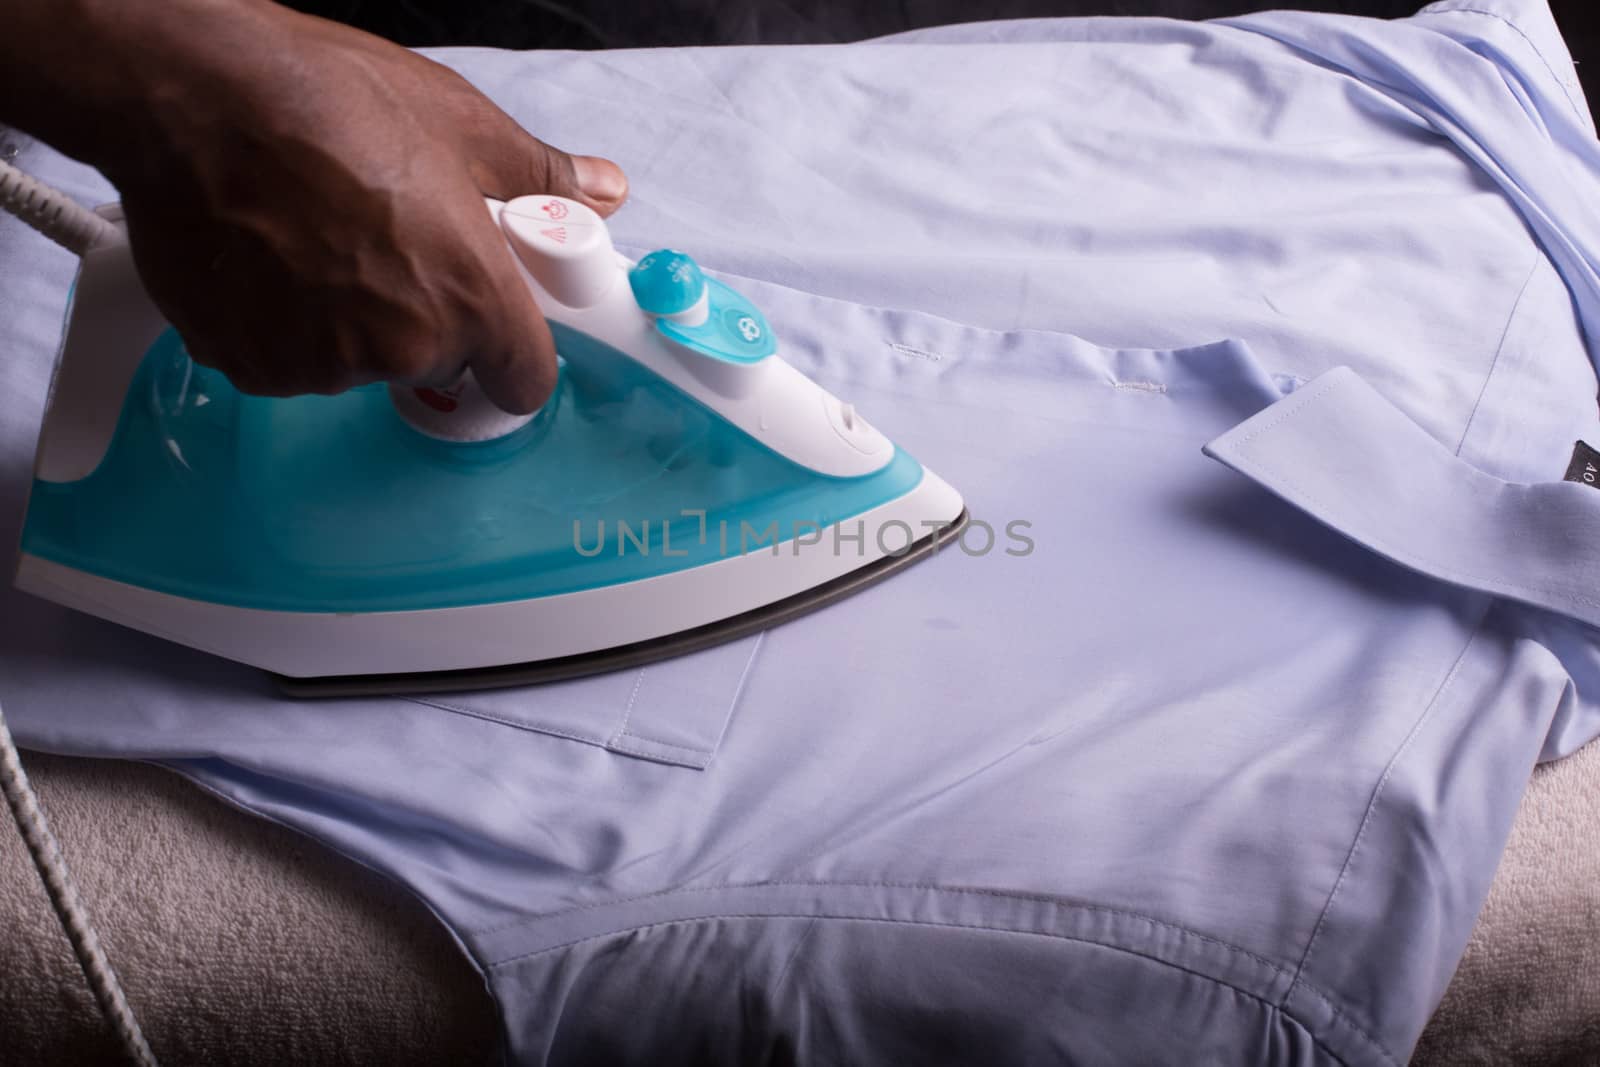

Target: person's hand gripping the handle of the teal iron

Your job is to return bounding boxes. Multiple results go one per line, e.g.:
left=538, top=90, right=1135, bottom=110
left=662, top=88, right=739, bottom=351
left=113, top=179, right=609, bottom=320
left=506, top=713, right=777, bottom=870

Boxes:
left=84, top=0, right=627, bottom=413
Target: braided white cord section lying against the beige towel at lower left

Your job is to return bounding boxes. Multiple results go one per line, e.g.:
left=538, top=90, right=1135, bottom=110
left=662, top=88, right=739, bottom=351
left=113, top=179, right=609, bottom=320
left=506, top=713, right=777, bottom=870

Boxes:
left=0, top=700, right=155, bottom=1067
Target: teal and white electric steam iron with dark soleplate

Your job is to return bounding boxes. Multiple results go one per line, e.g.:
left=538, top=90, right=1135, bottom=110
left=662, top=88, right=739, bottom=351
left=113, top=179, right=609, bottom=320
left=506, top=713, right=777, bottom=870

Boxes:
left=16, top=195, right=966, bottom=696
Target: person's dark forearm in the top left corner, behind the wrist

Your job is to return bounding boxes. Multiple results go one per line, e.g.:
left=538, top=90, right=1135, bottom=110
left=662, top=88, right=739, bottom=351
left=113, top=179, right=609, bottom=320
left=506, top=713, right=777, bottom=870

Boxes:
left=0, top=0, right=272, bottom=173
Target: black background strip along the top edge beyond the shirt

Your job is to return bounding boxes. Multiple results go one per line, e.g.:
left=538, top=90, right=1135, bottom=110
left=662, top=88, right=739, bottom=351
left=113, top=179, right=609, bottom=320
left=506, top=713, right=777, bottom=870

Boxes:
left=290, top=0, right=1600, bottom=119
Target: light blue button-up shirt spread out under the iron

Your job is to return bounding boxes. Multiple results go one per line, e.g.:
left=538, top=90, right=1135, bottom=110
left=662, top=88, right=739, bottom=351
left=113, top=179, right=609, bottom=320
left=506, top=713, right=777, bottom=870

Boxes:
left=0, top=0, right=1600, bottom=1065
